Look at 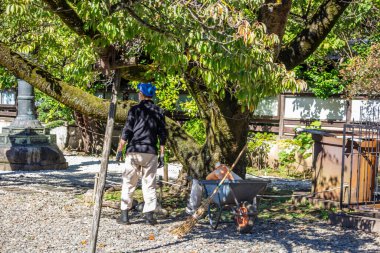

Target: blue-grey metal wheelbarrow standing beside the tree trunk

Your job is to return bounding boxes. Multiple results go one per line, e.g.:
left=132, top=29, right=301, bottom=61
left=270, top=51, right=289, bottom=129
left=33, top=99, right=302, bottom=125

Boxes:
left=199, top=179, right=270, bottom=233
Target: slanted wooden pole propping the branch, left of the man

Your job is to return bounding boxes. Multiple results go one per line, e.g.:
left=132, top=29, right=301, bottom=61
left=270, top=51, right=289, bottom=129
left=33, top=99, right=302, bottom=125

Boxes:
left=89, top=70, right=120, bottom=253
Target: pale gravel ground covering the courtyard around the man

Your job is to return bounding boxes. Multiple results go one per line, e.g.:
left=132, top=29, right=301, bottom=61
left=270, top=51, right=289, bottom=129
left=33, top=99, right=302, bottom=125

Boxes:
left=0, top=156, right=380, bottom=252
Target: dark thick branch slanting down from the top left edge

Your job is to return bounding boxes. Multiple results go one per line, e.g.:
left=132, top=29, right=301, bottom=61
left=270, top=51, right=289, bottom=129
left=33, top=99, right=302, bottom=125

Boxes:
left=43, top=0, right=101, bottom=39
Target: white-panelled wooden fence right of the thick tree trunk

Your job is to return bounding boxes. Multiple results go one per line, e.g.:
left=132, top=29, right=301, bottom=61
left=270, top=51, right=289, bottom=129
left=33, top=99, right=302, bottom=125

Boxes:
left=250, top=93, right=380, bottom=136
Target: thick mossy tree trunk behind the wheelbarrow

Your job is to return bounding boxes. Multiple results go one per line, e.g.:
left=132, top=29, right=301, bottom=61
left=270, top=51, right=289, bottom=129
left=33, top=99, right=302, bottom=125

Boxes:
left=186, top=74, right=249, bottom=178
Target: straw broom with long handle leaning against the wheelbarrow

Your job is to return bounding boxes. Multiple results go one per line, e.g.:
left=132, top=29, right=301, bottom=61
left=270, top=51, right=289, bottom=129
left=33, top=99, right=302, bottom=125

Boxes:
left=170, top=144, right=247, bottom=238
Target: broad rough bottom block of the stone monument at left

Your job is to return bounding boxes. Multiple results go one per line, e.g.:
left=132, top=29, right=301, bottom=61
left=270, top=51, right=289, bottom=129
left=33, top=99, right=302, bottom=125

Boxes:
left=0, top=143, right=68, bottom=171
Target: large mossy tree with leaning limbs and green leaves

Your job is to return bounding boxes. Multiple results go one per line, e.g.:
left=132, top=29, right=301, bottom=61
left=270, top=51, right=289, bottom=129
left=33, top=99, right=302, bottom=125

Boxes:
left=0, top=0, right=360, bottom=177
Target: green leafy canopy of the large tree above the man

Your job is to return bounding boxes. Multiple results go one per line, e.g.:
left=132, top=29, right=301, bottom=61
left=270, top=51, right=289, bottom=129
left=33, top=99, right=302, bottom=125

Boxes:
left=1, top=1, right=296, bottom=109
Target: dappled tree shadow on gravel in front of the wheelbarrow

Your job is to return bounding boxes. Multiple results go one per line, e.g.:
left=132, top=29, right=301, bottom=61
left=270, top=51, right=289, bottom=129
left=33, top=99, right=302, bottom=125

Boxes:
left=168, top=221, right=380, bottom=252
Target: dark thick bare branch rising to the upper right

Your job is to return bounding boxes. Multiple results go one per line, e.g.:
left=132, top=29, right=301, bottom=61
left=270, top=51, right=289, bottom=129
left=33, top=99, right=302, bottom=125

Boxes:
left=278, top=0, right=352, bottom=69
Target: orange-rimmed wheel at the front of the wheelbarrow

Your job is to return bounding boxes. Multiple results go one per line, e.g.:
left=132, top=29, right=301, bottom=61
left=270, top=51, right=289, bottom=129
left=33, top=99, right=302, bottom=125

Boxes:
left=234, top=201, right=257, bottom=234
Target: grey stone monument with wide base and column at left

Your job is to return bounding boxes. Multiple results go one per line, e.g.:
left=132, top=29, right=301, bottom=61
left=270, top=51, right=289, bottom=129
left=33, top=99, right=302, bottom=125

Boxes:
left=0, top=80, right=67, bottom=170
